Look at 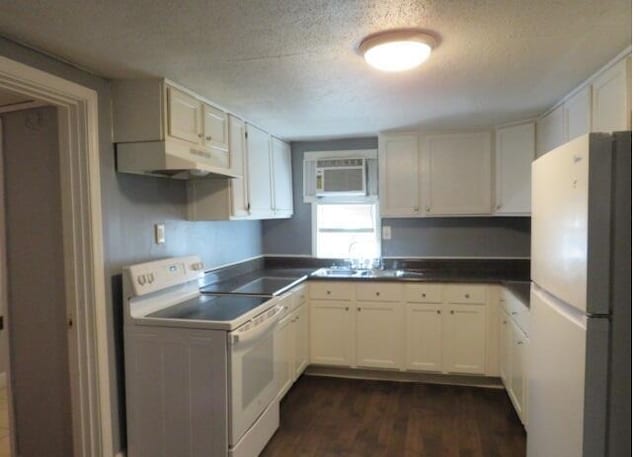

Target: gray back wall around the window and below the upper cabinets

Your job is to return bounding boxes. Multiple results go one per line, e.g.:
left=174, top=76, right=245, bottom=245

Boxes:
left=262, top=138, right=531, bottom=257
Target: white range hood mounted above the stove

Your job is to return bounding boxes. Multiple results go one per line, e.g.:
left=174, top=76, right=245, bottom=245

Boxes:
left=116, top=140, right=240, bottom=180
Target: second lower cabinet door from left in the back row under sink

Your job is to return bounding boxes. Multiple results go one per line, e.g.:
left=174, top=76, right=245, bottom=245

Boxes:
left=356, top=302, right=404, bottom=369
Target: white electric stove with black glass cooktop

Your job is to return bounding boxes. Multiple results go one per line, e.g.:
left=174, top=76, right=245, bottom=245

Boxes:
left=123, top=257, right=284, bottom=457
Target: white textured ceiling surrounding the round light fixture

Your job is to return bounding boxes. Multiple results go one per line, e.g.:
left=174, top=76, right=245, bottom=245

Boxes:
left=0, top=0, right=631, bottom=140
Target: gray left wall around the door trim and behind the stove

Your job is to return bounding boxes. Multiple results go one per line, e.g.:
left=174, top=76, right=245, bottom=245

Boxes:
left=0, top=38, right=262, bottom=449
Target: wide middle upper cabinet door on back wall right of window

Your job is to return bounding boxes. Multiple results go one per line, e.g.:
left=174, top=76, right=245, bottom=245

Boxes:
left=423, top=133, right=492, bottom=216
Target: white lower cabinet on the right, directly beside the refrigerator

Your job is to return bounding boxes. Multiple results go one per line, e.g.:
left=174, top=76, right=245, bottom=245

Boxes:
left=500, top=289, right=529, bottom=426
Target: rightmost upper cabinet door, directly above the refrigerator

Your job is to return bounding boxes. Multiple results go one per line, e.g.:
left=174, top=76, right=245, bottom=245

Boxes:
left=592, top=58, right=631, bottom=132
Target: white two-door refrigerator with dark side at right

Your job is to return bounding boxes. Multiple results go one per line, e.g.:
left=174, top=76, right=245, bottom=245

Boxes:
left=527, top=132, right=631, bottom=457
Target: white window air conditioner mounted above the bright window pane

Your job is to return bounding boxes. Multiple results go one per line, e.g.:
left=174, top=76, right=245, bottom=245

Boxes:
left=315, top=158, right=367, bottom=197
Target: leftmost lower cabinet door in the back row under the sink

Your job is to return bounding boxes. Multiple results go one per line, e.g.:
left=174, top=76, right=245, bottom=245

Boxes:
left=309, top=301, right=355, bottom=366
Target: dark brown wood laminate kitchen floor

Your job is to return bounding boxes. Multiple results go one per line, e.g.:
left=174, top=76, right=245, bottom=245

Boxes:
left=260, top=376, right=526, bottom=457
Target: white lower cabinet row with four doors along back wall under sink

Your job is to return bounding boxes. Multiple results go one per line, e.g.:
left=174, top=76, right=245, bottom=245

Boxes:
left=309, top=281, right=487, bottom=375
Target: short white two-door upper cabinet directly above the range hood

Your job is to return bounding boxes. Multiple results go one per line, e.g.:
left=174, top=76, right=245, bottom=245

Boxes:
left=112, top=79, right=229, bottom=169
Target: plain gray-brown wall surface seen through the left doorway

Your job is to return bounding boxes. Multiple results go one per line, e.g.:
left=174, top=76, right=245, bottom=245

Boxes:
left=1, top=107, right=73, bottom=457
